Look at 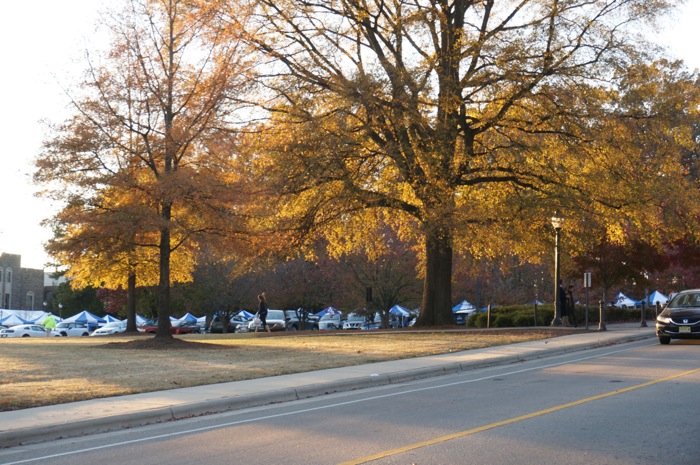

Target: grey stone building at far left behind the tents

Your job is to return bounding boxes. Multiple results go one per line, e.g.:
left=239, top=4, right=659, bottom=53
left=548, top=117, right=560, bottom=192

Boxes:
left=0, top=253, right=44, bottom=310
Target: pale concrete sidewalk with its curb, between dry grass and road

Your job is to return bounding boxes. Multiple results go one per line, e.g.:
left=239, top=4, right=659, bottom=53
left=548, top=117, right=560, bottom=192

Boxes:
left=0, top=323, right=655, bottom=447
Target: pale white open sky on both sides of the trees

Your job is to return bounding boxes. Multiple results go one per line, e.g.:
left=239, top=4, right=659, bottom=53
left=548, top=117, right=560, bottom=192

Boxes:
left=0, top=0, right=700, bottom=268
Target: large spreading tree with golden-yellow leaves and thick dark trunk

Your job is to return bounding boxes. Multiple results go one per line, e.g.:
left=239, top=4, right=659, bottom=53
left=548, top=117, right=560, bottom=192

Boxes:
left=232, top=0, right=692, bottom=325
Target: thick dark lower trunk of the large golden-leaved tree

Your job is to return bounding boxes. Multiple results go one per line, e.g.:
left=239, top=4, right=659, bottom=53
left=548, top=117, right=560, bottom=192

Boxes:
left=416, top=226, right=455, bottom=326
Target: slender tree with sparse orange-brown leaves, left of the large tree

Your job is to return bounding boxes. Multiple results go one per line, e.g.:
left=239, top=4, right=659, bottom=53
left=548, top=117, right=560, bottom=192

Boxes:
left=35, top=0, right=254, bottom=339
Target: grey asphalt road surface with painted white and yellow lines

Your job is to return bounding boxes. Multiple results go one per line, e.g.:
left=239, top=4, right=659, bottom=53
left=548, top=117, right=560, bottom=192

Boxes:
left=0, top=340, right=700, bottom=465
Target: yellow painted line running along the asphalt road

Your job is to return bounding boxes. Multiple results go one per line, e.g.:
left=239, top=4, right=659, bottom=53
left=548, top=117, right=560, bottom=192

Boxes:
left=339, top=368, right=700, bottom=465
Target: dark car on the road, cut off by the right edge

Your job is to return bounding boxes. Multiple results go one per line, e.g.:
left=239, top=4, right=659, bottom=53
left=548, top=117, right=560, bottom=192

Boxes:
left=656, top=289, right=700, bottom=344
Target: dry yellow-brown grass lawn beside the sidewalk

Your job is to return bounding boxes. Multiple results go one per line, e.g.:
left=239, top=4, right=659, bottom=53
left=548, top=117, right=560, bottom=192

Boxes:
left=0, top=329, right=576, bottom=411
